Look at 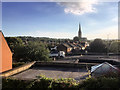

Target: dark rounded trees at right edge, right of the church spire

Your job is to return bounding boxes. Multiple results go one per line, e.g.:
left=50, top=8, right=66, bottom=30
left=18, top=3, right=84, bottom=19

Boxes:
left=89, top=39, right=120, bottom=54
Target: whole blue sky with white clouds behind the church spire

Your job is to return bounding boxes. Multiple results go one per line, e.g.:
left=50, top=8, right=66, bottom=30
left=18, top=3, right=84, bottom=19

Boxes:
left=2, top=0, right=118, bottom=39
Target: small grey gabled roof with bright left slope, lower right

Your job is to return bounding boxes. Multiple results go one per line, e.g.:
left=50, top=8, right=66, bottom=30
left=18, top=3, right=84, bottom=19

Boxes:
left=91, top=62, right=119, bottom=77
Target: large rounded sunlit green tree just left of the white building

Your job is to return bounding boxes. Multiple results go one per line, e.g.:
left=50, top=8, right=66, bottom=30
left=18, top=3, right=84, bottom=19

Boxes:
left=28, top=42, right=49, bottom=61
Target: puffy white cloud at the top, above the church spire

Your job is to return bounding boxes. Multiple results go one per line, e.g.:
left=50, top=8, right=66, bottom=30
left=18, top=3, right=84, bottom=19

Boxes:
left=58, top=0, right=97, bottom=15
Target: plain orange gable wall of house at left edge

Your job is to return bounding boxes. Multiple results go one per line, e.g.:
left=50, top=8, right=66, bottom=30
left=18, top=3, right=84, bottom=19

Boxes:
left=0, top=31, right=12, bottom=73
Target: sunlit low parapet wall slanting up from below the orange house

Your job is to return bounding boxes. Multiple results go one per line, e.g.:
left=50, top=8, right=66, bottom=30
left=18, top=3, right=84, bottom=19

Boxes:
left=0, top=61, right=36, bottom=77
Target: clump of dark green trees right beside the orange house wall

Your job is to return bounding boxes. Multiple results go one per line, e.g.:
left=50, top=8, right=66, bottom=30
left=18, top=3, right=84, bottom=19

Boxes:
left=6, top=37, right=50, bottom=62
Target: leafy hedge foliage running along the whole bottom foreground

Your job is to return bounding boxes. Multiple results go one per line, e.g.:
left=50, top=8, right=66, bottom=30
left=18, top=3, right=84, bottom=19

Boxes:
left=2, top=76, right=120, bottom=90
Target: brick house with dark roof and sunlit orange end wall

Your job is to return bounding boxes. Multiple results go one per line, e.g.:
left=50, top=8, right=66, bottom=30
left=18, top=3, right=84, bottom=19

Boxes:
left=57, top=43, right=72, bottom=54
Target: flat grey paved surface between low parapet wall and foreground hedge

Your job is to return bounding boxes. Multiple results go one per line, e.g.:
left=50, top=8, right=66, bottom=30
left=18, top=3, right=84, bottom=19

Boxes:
left=12, top=67, right=88, bottom=81
